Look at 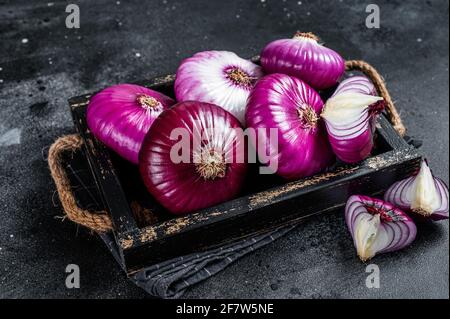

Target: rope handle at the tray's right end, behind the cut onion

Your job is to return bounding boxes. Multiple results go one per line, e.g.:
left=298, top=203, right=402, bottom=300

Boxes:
left=345, top=60, right=406, bottom=137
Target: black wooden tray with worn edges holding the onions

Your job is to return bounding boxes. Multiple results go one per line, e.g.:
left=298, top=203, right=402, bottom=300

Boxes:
left=69, top=69, right=421, bottom=274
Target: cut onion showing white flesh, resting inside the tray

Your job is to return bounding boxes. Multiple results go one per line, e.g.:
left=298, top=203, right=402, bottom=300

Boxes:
left=321, top=76, right=384, bottom=163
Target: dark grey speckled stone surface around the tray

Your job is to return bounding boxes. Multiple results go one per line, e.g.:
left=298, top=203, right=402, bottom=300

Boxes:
left=0, top=0, right=449, bottom=298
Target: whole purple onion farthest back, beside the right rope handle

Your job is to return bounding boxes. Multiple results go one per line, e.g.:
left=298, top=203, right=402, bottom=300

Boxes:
left=261, top=32, right=345, bottom=90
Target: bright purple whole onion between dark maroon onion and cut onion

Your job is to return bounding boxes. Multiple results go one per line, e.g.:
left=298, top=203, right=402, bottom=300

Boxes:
left=246, top=74, right=335, bottom=180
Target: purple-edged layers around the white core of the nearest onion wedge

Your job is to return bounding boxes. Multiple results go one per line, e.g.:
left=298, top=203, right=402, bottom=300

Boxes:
left=345, top=195, right=417, bottom=260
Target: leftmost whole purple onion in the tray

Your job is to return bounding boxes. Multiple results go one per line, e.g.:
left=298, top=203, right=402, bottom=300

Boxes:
left=86, top=84, right=175, bottom=164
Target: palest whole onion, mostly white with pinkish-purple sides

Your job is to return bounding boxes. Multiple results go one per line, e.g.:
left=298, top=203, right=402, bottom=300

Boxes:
left=175, top=51, right=263, bottom=125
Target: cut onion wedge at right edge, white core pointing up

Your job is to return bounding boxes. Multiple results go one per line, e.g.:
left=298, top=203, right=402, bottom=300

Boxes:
left=384, top=161, right=448, bottom=220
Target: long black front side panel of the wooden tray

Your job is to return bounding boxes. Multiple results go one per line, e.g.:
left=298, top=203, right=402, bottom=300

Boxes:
left=120, top=152, right=421, bottom=272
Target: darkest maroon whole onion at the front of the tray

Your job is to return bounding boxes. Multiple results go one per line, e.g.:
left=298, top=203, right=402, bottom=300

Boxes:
left=139, top=101, right=247, bottom=214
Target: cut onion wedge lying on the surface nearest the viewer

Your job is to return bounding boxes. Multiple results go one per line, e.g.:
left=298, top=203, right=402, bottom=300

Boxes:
left=345, top=195, right=417, bottom=261
